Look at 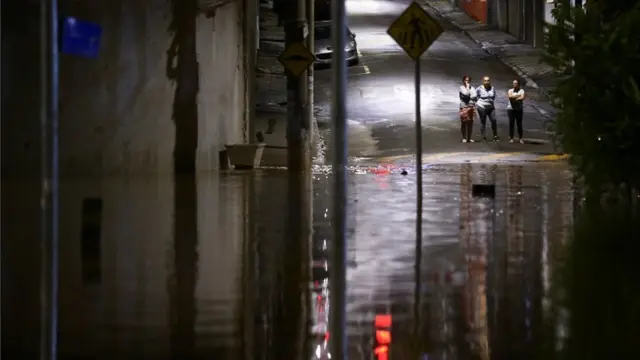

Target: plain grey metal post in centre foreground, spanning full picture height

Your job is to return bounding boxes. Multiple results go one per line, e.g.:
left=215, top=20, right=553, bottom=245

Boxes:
left=329, top=0, right=347, bottom=360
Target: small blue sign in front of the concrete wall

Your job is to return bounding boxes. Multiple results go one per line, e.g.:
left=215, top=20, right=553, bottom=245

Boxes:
left=62, top=17, right=102, bottom=58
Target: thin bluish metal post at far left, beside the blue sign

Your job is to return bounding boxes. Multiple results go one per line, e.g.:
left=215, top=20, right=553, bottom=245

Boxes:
left=40, top=0, right=59, bottom=360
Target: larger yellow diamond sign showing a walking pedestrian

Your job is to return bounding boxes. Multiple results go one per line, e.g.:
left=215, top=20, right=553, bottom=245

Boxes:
left=387, top=2, right=444, bottom=60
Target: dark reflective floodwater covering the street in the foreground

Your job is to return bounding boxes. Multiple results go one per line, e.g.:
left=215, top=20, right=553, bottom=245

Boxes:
left=2, top=164, right=574, bottom=360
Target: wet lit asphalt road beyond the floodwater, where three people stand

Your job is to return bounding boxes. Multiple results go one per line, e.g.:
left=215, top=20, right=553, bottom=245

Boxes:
left=315, top=0, right=552, bottom=157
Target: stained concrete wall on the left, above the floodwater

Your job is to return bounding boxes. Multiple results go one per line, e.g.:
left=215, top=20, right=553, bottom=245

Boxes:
left=2, top=0, right=256, bottom=174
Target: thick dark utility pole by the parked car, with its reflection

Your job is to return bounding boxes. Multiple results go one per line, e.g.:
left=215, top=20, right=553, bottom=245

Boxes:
left=275, top=0, right=313, bottom=360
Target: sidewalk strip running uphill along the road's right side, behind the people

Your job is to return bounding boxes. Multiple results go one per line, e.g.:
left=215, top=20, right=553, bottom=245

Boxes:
left=421, top=0, right=556, bottom=97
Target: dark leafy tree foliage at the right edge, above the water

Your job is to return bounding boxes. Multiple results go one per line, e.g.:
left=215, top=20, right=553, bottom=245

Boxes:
left=544, top=0, right=640, bottom=190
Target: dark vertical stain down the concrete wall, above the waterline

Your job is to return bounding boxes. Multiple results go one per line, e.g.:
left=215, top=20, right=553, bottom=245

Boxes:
left=166, top=0, right=199, bottom=173
